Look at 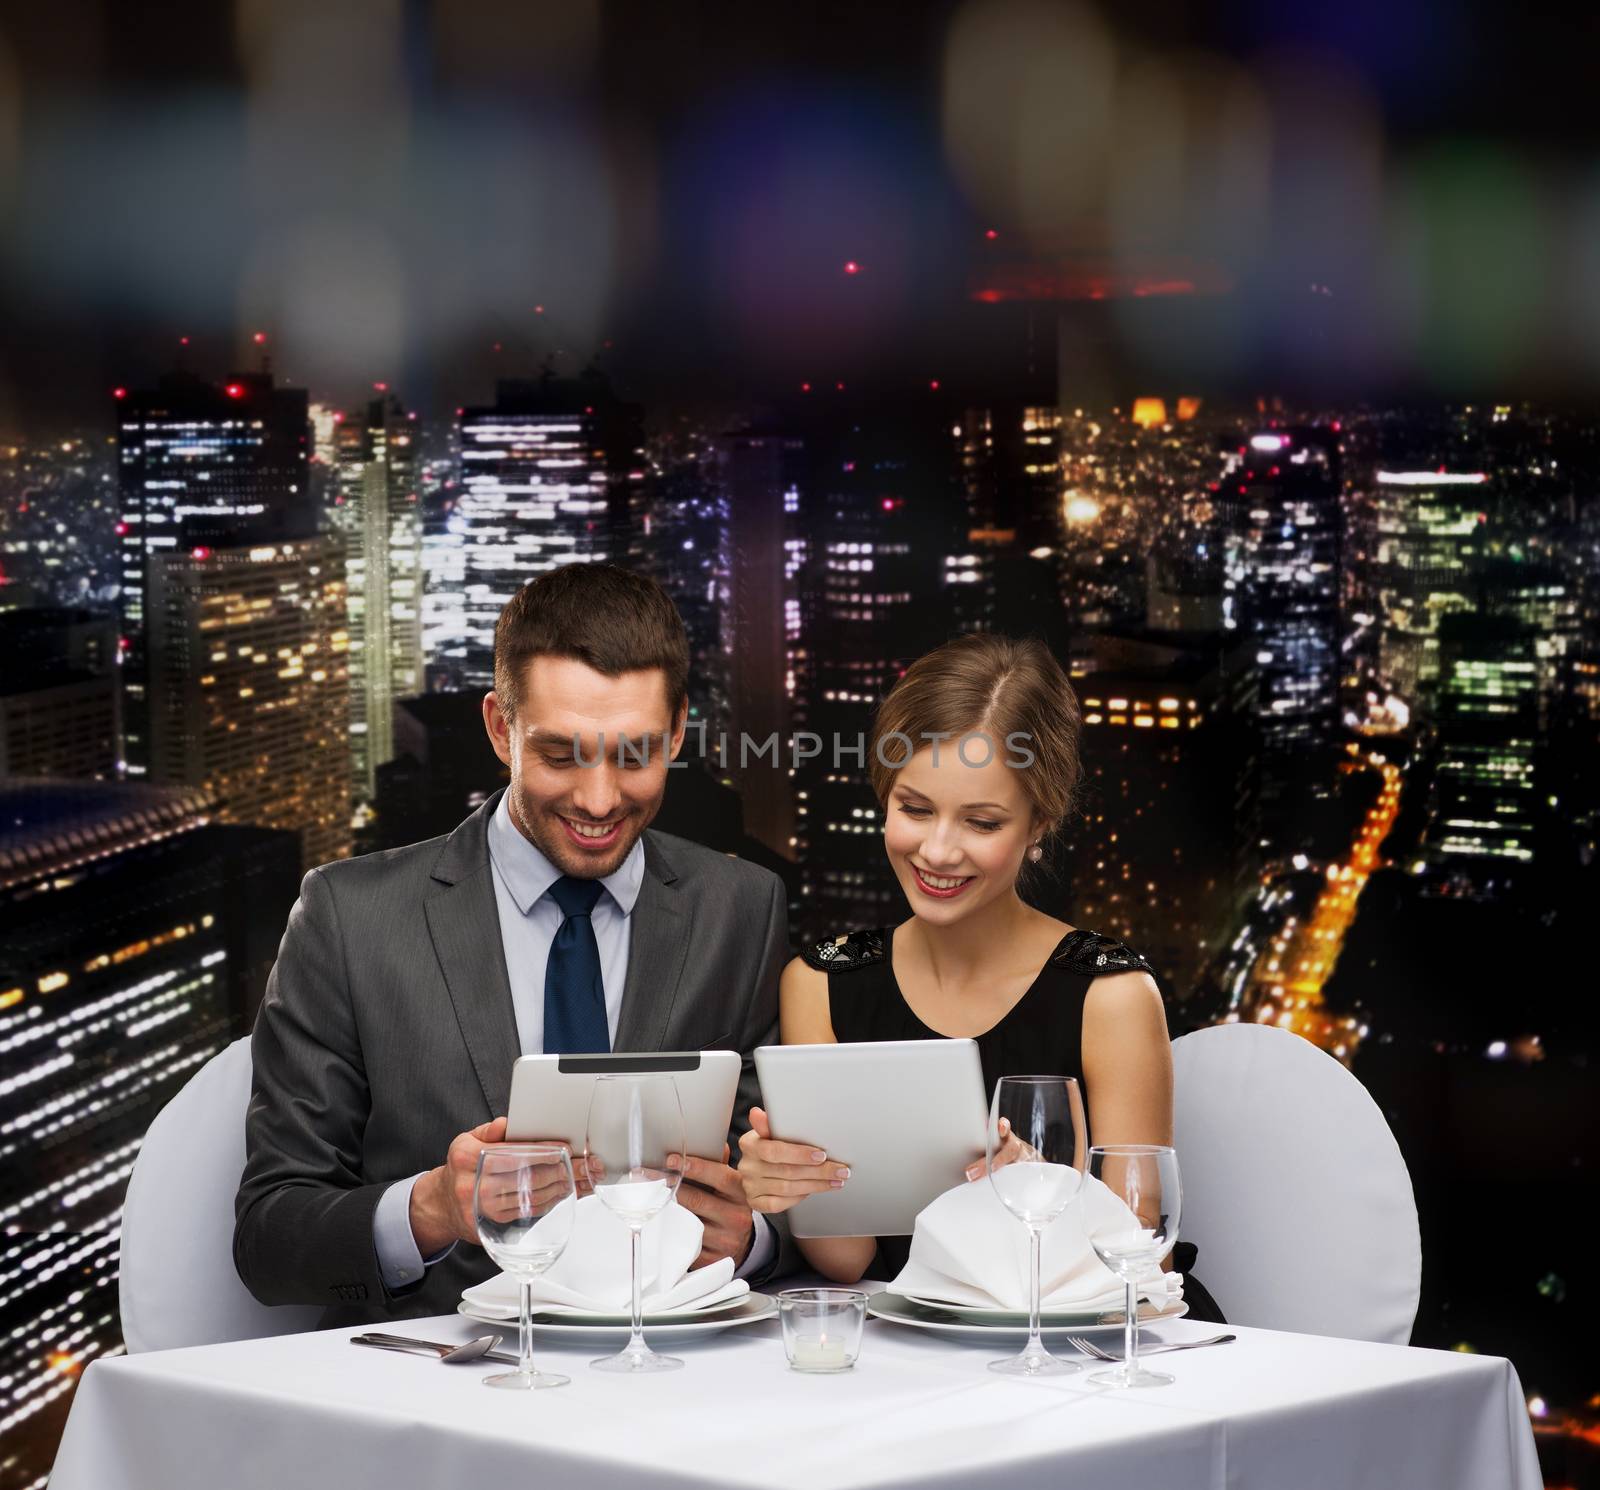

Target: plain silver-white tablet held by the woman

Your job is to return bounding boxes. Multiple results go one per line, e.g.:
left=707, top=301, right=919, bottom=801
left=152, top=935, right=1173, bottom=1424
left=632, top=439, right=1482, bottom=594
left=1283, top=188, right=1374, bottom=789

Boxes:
left=755, top=1040, right=989, bottom=1237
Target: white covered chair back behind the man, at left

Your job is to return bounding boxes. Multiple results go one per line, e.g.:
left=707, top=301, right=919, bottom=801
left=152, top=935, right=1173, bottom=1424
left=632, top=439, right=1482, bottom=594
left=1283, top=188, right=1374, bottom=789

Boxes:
left=118, top=1035, right=322, bottom=1352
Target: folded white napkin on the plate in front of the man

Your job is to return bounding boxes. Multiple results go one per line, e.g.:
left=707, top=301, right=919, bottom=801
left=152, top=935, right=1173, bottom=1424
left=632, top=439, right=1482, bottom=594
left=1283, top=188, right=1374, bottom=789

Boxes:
left=461, top=1196, right=750, bottom=1319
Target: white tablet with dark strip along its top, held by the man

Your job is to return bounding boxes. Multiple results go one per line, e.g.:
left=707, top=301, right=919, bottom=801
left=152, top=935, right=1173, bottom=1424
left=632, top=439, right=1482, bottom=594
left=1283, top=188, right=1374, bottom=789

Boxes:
left=506, top=1050, right=742, bottom=1160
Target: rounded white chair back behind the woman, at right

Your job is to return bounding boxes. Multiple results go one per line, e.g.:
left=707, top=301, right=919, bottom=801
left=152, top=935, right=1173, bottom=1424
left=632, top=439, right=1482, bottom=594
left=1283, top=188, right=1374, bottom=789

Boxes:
left=1173, top=1024, right=1422, bottom=1344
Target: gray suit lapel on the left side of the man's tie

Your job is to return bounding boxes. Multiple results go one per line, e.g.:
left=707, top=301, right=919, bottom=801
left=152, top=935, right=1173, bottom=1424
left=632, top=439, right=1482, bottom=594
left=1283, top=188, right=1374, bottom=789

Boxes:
left=426, top=792, right=522, bottom=1117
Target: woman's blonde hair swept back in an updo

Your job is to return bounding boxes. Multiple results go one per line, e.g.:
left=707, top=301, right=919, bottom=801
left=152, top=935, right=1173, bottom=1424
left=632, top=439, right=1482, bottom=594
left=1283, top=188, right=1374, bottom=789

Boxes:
left=867, top=632, right=1082, bottom=867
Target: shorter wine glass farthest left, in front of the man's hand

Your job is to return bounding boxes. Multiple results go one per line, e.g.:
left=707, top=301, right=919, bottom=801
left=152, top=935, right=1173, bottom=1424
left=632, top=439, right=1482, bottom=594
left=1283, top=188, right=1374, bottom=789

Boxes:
left=472, top=1143, right=578, bottom=1391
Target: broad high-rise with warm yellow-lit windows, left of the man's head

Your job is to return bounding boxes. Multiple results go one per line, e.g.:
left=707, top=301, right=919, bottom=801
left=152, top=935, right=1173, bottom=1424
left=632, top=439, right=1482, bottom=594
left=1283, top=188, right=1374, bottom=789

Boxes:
left=149, top=533, right=350, bottom=869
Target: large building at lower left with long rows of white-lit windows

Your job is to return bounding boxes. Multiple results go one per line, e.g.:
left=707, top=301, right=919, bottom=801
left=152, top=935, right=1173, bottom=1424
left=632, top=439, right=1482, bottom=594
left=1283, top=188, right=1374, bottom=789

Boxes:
left=0, top=781, right=299, bottom=1487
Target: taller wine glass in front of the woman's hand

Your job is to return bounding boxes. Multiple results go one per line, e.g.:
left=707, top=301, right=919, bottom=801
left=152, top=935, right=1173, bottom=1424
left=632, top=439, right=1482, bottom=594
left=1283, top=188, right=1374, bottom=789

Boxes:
left=984, top=1075, right=1088, bottom=1376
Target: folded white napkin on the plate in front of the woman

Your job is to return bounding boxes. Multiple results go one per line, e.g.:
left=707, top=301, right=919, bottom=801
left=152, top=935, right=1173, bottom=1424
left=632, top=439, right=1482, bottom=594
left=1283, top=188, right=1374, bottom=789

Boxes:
left=888, top=1178, right=1184, bottom=1312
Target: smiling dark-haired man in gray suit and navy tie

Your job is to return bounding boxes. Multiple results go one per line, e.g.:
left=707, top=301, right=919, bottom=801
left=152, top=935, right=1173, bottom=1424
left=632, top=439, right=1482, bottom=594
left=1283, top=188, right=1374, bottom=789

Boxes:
left=234, top=565, right=789, bottom=1327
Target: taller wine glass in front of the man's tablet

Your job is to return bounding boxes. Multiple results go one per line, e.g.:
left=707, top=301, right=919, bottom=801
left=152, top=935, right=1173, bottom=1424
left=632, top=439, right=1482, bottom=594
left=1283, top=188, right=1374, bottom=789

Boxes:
left=584, top=1074, right=688, bottom=1372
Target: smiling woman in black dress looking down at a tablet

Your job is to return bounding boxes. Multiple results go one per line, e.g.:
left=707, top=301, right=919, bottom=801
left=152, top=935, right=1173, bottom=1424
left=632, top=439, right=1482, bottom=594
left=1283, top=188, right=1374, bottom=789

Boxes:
left=739, top=634, right=1216, bottom=1317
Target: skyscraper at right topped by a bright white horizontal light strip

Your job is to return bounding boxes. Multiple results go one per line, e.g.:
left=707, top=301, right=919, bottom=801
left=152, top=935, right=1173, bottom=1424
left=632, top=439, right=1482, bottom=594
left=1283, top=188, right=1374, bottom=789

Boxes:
left=1371, top=471, right=1488, bottom=712
